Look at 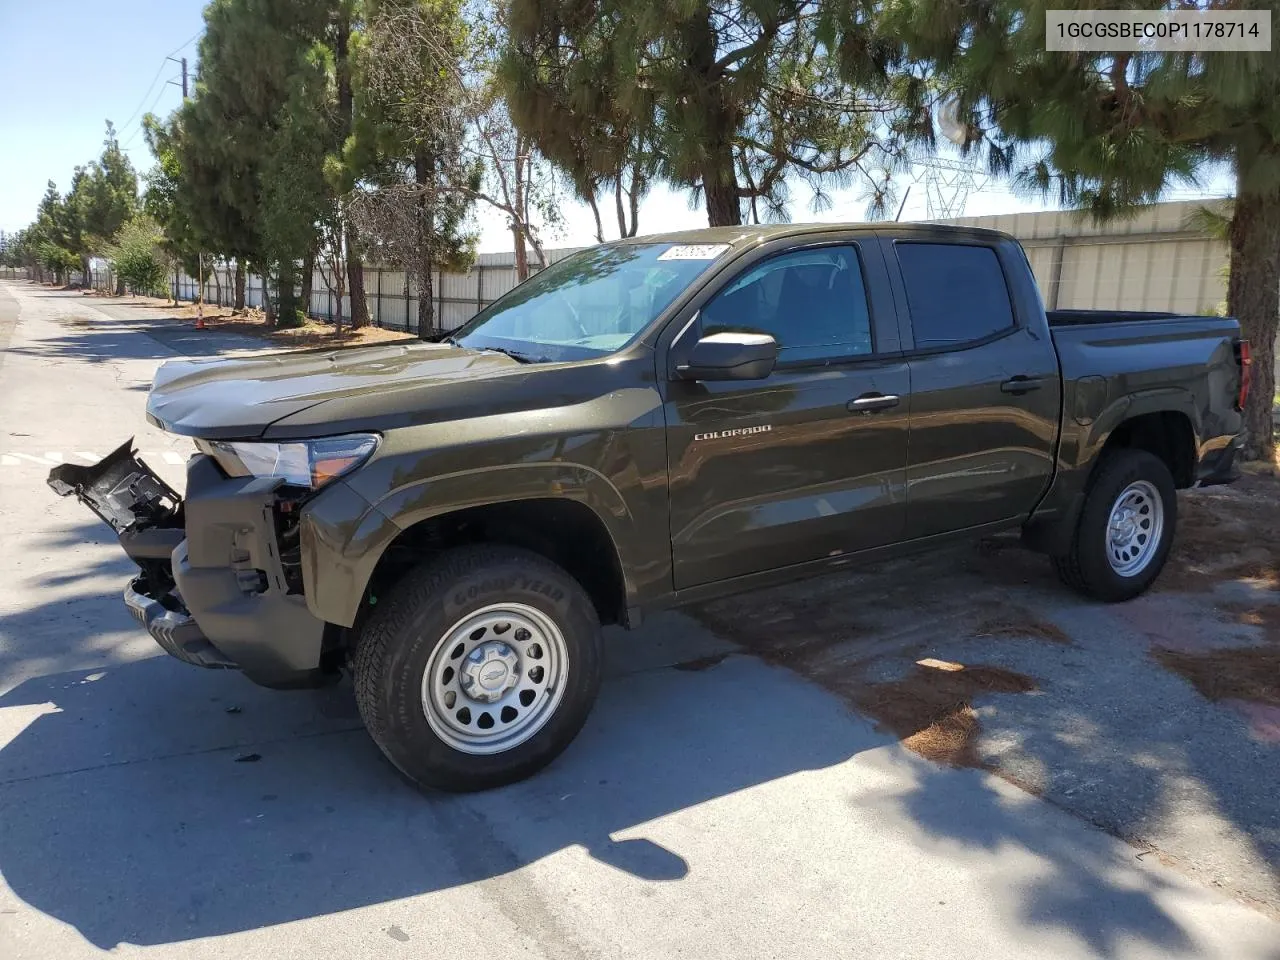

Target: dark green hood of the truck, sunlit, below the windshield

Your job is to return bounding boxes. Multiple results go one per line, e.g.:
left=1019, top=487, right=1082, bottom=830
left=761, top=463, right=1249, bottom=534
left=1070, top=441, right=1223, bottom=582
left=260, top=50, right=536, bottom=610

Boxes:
left=147, top=343, right=521, bottom=440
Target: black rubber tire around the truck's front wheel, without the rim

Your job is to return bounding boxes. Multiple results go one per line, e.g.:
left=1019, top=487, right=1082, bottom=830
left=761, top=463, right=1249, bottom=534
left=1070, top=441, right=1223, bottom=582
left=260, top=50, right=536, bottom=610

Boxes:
left=353, top=545, right=602, bottom=791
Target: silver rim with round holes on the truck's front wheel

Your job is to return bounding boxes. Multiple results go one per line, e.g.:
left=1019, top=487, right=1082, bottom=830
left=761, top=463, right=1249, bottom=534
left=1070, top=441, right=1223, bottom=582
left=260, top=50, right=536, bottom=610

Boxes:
left=422, top=603, right=568, bottom=754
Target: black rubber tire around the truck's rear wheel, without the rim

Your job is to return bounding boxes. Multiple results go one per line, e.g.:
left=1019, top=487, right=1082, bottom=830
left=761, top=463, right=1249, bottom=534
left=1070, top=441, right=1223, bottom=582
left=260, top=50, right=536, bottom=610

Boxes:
left=1053, top=449, right=1178, bottom=603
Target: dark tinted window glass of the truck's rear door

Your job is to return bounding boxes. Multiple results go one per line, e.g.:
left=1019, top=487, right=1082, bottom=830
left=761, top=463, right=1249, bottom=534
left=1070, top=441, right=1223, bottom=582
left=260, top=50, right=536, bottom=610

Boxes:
left=893, top=241, right=1014, bottom=349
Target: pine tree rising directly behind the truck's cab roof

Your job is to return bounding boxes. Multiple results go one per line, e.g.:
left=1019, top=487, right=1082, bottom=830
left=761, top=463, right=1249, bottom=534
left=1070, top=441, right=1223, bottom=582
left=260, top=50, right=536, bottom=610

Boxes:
left=503, top=0, right=919, bottom=225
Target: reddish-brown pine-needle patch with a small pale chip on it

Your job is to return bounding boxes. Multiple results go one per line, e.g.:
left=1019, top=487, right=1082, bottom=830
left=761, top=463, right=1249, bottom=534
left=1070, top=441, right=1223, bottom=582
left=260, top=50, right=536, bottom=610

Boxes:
left=850, top=659, right=1036, bottom=767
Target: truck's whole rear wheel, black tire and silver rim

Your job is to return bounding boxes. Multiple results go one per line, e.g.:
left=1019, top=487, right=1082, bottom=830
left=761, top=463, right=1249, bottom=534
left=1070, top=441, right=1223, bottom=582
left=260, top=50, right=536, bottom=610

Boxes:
left=1053, top=449, right=1178, bottom=603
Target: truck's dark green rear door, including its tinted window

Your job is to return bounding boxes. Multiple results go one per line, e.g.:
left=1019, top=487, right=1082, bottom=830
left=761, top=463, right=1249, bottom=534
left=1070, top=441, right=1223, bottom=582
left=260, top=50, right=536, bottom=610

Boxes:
left=884, top=234, right=1061, bottom=538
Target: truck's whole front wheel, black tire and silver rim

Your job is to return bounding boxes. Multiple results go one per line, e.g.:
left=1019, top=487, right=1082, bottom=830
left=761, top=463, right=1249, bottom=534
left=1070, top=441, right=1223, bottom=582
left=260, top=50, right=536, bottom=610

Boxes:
left=353, top=547, right=600, bottom=791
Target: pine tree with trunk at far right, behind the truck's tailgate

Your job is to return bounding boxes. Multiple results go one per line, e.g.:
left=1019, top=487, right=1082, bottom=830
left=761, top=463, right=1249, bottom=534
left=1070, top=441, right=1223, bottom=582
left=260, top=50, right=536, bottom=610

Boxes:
left=849, top=0, right=1280, bottom=460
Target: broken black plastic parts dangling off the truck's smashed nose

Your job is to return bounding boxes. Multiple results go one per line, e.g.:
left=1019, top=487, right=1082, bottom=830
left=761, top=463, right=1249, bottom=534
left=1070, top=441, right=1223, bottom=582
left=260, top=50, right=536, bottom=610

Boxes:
left=49, top=438, right=238, bottom=668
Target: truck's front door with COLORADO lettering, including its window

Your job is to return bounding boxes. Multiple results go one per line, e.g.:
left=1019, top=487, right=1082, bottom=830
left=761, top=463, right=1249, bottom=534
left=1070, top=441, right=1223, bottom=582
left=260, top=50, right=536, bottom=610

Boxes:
left=664, top=242, right=910, bottom=590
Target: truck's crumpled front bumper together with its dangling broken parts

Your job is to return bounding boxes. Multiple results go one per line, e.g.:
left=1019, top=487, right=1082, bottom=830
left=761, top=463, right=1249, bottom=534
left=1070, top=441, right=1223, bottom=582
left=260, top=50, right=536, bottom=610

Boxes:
left=50, top=444, right=326, bottom=686
